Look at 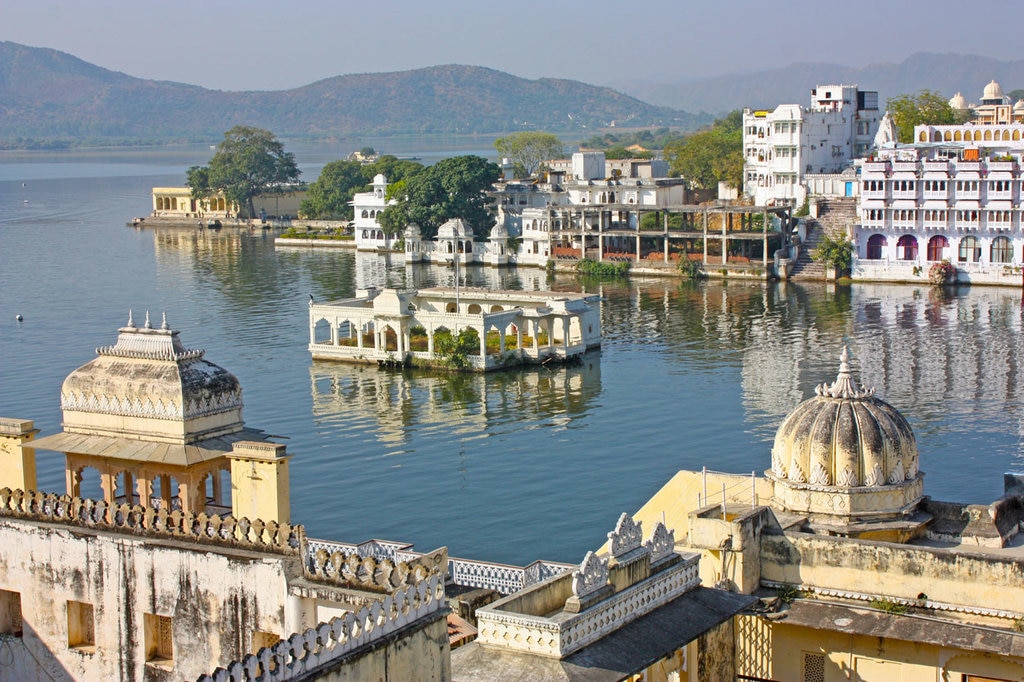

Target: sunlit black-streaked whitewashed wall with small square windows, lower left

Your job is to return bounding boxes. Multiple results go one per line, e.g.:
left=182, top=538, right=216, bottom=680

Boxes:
left=0, top=517, right=301, bottom=680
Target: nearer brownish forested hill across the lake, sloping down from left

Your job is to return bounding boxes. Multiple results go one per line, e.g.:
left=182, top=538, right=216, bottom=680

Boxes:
left=0, top=42, right=710, bottom=146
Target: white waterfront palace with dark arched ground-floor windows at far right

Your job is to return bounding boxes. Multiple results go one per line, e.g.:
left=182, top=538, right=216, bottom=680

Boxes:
left=852, top=82, right=1024, bottom=286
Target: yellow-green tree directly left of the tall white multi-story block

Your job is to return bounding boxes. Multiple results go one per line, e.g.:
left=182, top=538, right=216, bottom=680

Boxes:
left=665, top=110, right=743, bottom=189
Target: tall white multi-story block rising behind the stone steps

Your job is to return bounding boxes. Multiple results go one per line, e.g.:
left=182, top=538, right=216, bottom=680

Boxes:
left=743, top=85, right=881, bottom=206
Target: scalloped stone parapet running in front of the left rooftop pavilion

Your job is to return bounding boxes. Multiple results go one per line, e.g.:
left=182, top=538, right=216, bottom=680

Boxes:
left=0, top=487, right=305, bottom=555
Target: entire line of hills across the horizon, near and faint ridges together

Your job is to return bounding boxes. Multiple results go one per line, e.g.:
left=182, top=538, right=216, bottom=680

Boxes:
left=0, top=42, right=1024, bottom=148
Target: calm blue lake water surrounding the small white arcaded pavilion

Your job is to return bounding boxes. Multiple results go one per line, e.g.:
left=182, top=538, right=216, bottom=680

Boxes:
left=0, top=147, right=1024, bottom=564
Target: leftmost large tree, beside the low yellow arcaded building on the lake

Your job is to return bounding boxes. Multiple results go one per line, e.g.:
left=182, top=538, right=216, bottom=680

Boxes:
left=185, top=126, right=300, bottom=216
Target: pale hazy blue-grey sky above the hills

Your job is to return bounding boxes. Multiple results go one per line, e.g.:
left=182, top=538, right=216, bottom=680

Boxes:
left=0, top=0, right=1024, bottom=90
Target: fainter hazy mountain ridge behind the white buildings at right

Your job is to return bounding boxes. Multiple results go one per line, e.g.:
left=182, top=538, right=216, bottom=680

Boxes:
left=617, top=52, right=1024, bottom=116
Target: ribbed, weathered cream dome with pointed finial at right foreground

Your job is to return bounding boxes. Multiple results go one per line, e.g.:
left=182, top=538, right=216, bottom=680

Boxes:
left=767, top=348, right=924, bottom=520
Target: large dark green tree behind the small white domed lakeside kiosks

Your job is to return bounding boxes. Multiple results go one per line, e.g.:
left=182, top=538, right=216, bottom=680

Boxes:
left=377, top=156, right=502, bottom=239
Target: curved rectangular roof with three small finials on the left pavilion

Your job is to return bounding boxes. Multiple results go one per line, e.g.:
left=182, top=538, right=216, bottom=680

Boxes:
left=60, top=313, right=245, bottom=443
